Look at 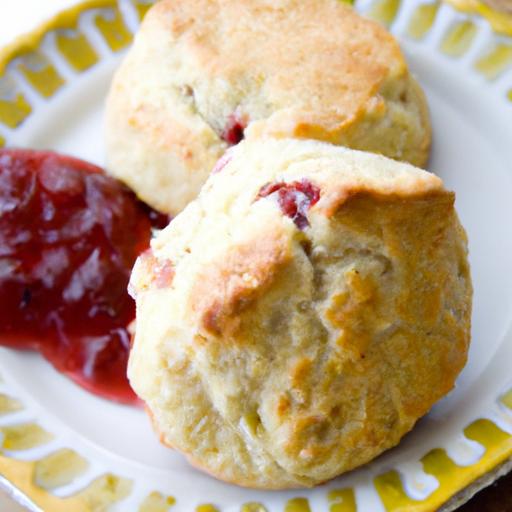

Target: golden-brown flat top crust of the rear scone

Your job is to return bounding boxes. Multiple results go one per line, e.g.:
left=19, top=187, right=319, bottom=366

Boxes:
left=146, top=0, right=407, bottom=134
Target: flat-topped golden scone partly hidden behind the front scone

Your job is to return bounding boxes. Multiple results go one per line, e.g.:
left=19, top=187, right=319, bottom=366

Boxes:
left=107, top=0, right=431, bottom=215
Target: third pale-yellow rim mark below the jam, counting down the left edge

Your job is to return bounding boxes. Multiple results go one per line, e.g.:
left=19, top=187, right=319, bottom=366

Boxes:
left=34, top=448, right=89, bottom=491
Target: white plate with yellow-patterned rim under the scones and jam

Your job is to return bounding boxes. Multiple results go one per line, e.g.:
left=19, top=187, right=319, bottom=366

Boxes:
left=0, top=0, right=512, bottom=512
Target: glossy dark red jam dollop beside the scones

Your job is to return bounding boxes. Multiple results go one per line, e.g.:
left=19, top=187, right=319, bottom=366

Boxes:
left=0, top=149, right=168, bottom=403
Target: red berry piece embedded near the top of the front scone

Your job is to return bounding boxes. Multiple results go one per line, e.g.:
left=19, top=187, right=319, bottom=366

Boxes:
left=258, top=179, right=320, bottom=229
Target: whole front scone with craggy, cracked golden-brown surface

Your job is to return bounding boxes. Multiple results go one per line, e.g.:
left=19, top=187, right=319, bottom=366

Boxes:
left=129, top=139, right=472, bottom=488
